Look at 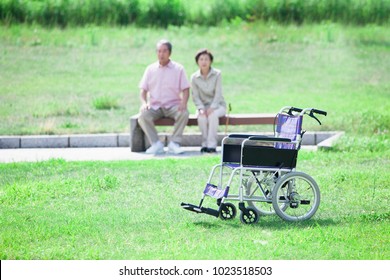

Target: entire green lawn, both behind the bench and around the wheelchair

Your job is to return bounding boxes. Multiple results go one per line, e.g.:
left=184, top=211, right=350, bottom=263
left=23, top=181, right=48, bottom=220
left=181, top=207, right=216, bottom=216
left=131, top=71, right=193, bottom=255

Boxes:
left=0, top=21, right=390, bottom=260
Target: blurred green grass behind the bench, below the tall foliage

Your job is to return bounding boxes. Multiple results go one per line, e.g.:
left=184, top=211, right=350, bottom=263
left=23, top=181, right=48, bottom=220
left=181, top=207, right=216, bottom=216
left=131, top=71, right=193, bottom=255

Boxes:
left=0, top=22, right=390, bottom=135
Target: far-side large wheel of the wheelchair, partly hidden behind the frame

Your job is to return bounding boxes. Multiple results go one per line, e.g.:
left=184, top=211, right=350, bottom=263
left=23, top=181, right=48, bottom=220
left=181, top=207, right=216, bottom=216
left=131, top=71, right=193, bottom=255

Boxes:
left=244, top=172, right=288, bottom=216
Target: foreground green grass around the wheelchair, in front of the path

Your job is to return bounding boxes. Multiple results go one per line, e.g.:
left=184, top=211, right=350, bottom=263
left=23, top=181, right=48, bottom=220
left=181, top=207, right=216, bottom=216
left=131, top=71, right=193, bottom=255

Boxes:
left=0, top=143, right=390, bottom=260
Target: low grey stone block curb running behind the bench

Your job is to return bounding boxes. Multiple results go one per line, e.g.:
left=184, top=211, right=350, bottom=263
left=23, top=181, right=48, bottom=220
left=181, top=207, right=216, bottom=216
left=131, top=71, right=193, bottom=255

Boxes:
left=0, top=131, right=344, bottom=149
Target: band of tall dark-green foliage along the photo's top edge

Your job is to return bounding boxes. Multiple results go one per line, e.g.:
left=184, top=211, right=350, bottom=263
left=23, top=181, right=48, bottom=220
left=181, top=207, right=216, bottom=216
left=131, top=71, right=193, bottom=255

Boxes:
left=0, top=0, right=390, bottom=27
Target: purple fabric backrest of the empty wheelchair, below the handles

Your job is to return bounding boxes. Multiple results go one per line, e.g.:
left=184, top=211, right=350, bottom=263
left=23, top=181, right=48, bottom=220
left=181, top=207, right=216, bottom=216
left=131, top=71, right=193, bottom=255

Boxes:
left=275, top=114, right=303, bottom=149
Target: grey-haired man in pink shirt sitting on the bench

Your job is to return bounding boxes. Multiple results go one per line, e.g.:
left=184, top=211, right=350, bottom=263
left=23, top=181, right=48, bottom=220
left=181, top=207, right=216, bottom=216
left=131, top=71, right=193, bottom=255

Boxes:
left=138, top=40, right=190, bottom=154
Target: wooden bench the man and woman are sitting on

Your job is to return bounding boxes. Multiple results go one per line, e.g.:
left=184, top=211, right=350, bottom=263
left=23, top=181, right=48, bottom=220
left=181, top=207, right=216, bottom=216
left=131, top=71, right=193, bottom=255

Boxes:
left=130, top=114, right=275, bottom=152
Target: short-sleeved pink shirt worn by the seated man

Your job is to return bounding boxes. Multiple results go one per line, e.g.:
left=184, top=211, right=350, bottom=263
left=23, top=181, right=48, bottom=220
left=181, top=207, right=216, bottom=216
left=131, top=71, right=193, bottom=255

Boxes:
left=139, top=61, right=190, bottom=110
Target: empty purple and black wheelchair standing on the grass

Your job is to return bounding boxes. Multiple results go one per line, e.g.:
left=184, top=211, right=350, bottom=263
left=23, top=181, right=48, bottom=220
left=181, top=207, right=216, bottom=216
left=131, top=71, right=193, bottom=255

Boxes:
left=181, top=106, right=327, bottom=224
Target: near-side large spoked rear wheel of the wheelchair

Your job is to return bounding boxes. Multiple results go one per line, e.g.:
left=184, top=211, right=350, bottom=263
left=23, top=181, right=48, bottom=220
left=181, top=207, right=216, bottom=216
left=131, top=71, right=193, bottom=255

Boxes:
left=272, top=172, right=320, bottom=222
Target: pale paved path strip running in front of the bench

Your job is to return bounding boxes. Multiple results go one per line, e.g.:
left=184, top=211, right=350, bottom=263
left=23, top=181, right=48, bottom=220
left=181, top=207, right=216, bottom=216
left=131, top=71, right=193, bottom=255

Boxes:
left=0, top=146, right=317, bottom=163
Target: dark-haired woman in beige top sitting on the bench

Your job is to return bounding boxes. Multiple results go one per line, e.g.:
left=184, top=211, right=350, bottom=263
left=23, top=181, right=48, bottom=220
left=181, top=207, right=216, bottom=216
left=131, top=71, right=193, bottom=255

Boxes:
left=191, top=49, right=226, bottom=153
